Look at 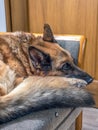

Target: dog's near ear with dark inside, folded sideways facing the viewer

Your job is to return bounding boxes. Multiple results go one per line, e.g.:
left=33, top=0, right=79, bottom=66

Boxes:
left=29, top=46, right=52, bottom=72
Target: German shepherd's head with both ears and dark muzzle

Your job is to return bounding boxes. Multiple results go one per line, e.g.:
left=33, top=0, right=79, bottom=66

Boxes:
left=29, top=24, right=93, bottom=84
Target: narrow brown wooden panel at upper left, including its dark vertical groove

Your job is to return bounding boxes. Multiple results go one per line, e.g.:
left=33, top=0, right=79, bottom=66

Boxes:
left=5, top=0, right=28, bottom=31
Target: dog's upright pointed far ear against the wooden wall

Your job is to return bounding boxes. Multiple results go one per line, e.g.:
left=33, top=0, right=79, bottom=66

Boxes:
left=43, top=24, right=56, bottom=42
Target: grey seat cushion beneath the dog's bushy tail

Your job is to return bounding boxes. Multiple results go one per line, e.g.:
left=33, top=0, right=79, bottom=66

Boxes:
left=0, top=108, right=80, bottom=130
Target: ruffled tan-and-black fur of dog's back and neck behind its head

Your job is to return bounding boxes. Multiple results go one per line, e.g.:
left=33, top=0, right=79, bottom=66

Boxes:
left=0, top=32, right=34, bottom=77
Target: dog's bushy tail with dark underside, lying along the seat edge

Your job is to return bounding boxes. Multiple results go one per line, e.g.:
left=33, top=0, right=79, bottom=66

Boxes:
left=0, top=76, right=94, bottom=124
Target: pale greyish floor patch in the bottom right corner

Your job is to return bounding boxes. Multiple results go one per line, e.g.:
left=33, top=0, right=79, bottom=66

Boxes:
left=82, top=108, right=98, bottom=130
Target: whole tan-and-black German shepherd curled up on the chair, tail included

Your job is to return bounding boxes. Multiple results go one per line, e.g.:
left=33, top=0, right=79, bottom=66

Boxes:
left=0, top=24, right=94, bottom=124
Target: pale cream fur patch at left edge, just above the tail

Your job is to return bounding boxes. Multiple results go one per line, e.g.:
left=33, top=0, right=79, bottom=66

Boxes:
left=0, top=61, right=15, bottom=96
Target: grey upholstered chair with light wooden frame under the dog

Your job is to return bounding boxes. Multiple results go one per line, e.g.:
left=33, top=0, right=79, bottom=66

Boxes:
left=0, top=35, right=95, bottom=130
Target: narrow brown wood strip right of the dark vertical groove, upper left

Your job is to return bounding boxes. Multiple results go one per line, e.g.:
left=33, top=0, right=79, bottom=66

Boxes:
left=10, top=0, right=28, bottom=31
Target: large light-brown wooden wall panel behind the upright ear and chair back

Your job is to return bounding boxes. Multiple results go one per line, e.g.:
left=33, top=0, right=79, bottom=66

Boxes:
left=28, top=0, right=98, bottom=79
